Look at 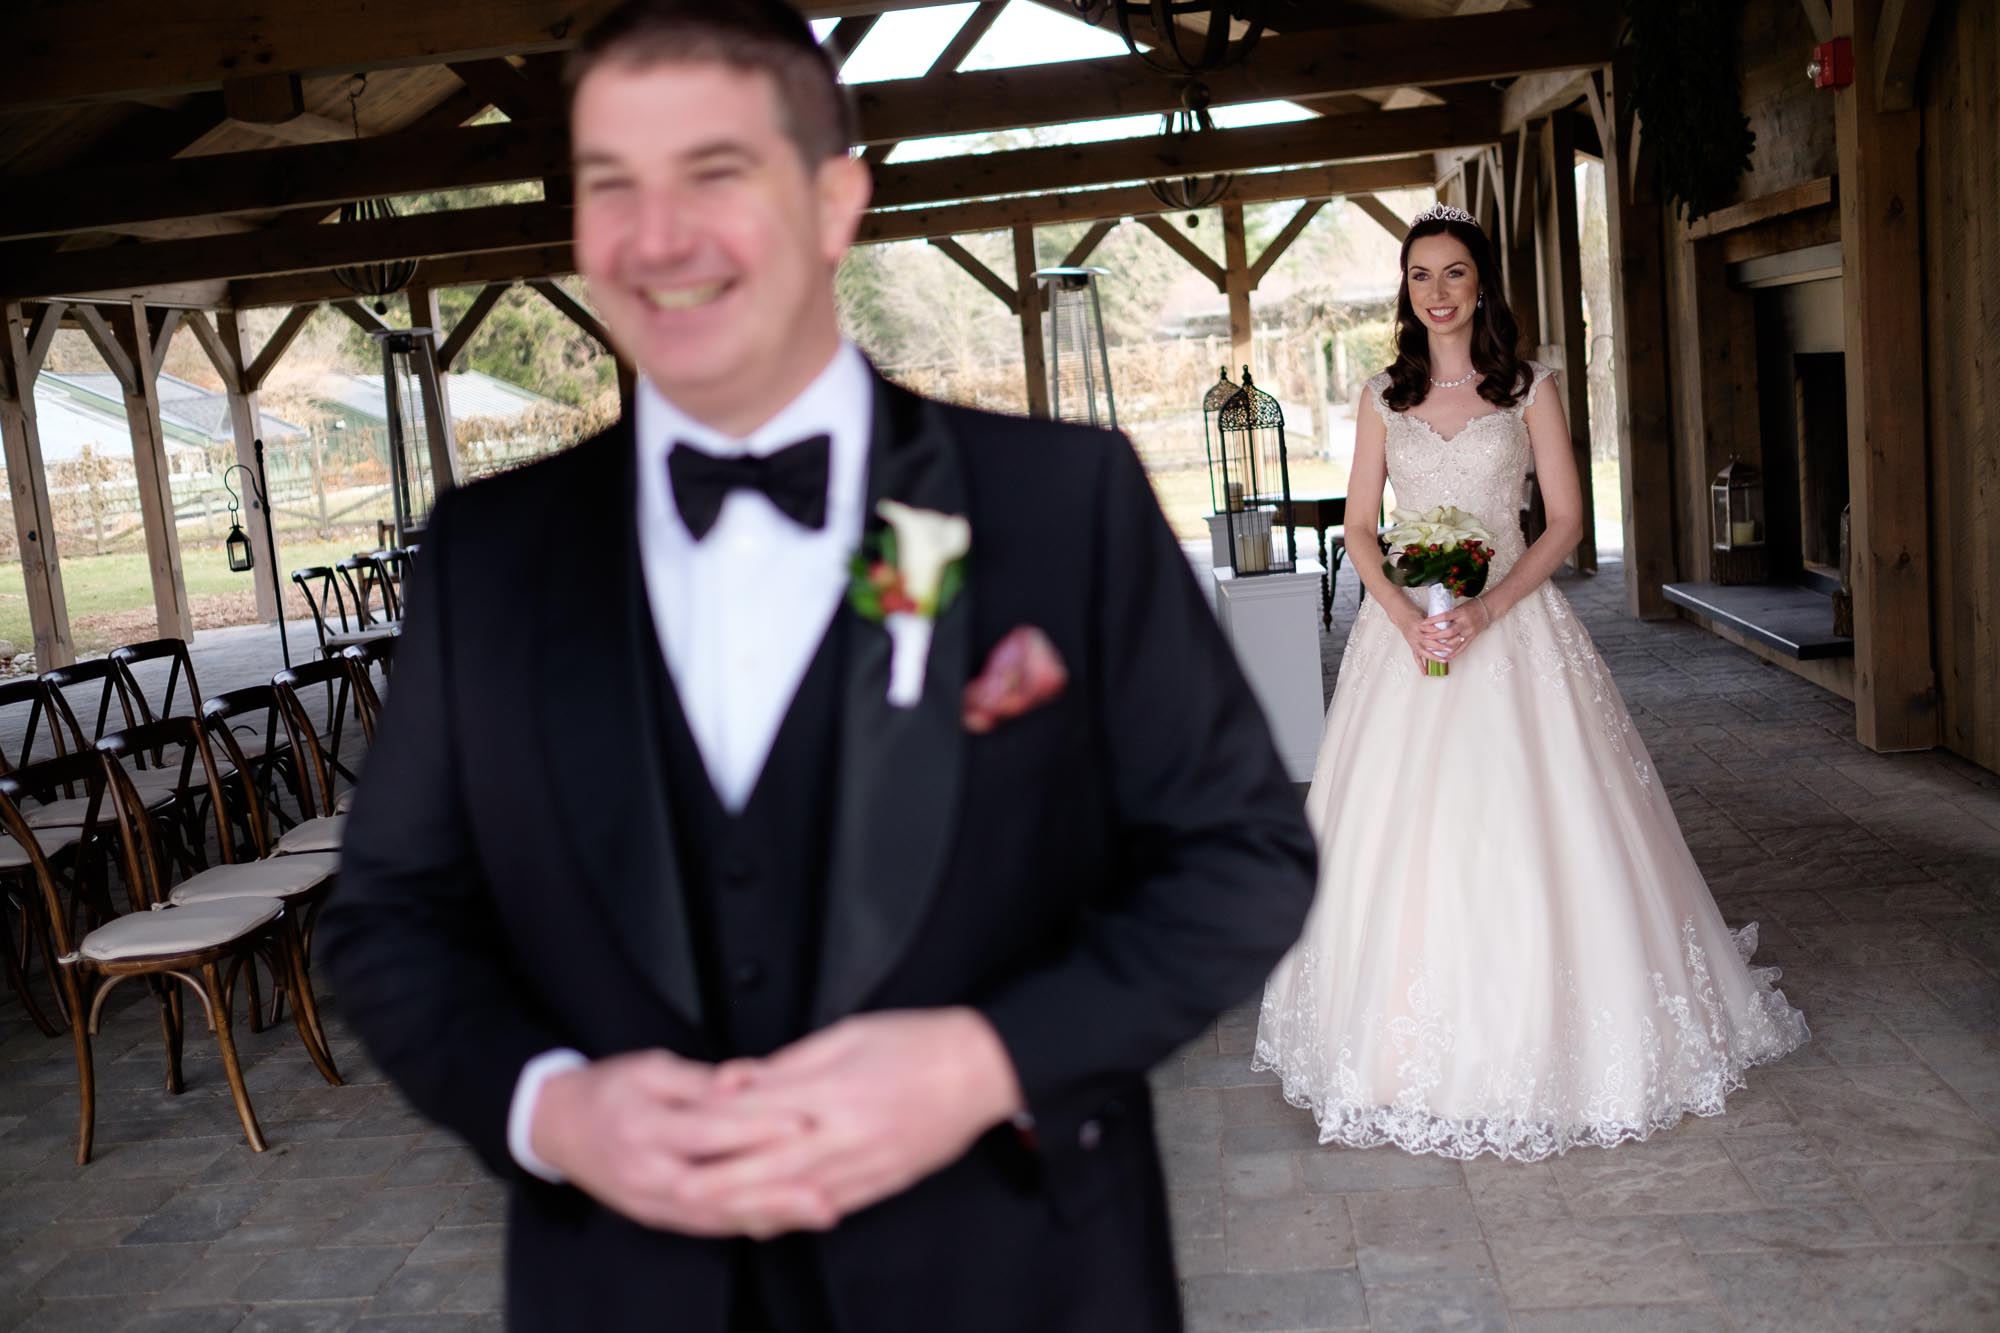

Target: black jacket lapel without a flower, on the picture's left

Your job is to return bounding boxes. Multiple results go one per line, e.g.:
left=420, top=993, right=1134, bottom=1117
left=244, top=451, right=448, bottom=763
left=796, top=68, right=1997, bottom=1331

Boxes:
left=528, top=422, right=702, bottom=1027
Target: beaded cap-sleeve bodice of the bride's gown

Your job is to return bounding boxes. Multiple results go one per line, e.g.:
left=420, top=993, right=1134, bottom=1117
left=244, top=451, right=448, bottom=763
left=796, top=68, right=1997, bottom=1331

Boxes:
left=1368, top=362, right=1554, bottom=582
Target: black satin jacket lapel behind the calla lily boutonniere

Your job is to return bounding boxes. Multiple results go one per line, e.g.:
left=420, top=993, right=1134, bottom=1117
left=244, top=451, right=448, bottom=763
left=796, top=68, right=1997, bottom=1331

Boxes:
left=812, top=376, right=980, bottom=1027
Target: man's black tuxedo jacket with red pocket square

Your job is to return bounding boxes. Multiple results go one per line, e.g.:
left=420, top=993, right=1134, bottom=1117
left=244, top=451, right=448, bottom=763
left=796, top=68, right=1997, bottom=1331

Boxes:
left=316, top=370, right=1314, bottom=1333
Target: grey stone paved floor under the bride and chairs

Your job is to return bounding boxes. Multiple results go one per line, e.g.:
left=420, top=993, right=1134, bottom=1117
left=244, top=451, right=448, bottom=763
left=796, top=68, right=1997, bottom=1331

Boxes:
left=0, top=568, right=2000, bottom=1333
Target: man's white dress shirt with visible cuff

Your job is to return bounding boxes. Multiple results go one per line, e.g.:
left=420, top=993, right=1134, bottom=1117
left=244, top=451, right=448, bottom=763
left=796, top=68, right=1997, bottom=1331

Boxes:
left=508, top=342, right=874, bottom=1181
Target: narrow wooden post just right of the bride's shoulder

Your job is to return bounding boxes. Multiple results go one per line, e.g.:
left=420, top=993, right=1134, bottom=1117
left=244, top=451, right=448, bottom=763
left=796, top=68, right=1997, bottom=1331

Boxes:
left=1536, top=114, right=1598, bottom=574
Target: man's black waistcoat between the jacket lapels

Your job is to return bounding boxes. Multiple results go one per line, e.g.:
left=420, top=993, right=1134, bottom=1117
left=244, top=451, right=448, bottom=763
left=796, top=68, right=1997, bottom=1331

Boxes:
left=648, top=612, right=846, bottom=1333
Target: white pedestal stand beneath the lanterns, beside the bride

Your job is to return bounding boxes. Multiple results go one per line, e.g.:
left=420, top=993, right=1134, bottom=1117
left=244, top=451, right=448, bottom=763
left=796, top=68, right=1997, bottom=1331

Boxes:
left=1216, top=560, right=1326, bottom=783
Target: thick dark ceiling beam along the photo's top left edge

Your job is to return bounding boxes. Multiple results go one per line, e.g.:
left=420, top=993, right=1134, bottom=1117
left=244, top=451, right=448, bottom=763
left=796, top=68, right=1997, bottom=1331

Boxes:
left=0, top=0, right=936, bottom=112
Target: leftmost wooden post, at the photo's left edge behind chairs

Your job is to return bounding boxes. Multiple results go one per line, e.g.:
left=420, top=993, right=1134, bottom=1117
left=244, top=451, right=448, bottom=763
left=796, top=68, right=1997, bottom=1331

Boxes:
left=0, top=302, right=76, bottom=671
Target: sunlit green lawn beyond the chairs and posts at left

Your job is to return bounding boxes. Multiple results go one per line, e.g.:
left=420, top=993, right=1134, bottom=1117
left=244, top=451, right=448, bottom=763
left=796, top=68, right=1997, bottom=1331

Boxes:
left=0, top=536, right=364, bottom=652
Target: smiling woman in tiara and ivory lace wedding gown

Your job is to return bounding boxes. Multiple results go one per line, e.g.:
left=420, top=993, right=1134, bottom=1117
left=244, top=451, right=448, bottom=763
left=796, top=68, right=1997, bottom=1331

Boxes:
left=1256, top=204, right=1808, bottom=1161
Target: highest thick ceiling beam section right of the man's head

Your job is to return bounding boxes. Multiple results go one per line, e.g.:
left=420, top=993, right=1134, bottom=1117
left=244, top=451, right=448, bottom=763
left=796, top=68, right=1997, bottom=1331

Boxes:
left=854, top=10, right=1614, bottom=144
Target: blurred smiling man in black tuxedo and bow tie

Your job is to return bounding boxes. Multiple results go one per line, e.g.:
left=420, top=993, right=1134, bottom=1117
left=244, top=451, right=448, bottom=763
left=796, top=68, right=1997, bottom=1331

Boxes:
left=318, top=0, right=1314, bottom=1333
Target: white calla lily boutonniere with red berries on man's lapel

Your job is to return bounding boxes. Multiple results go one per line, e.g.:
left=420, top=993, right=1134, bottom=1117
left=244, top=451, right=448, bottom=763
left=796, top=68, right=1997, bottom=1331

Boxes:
left=848, top=500, right=972, bottom=709
